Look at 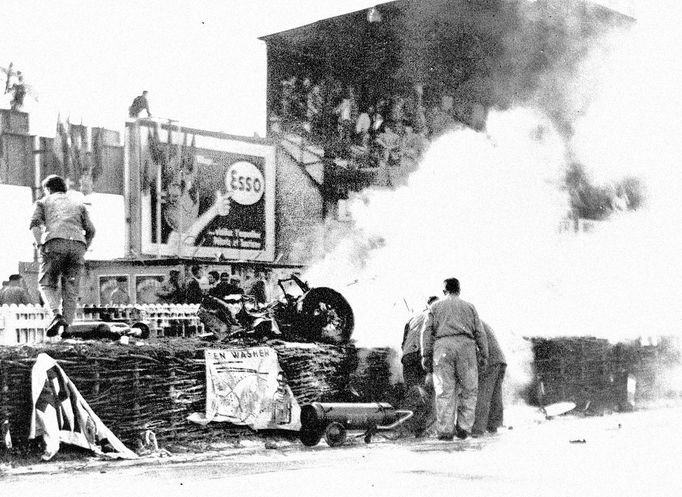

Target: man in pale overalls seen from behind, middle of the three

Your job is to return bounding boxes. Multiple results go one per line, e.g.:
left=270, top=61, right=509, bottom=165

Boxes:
left=422, top=278, right=488, bottom=440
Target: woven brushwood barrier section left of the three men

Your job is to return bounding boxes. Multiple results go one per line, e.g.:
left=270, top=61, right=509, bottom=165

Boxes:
left=0, top=338, right=366, bottom=448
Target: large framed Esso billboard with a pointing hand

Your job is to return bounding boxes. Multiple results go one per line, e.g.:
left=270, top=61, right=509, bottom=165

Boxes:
left=127, top=120, right=275, bottom=261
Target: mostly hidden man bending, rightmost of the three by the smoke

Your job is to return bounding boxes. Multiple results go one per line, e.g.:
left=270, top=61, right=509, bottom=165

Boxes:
left=471, top=323, right=507, bottom=437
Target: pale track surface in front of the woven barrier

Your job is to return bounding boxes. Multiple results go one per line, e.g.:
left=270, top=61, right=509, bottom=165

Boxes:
left=0, top=406, right=682, bottom=497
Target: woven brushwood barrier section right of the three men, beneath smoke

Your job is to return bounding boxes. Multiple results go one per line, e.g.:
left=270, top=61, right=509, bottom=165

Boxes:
left=528, top=336, right=682, bottom=414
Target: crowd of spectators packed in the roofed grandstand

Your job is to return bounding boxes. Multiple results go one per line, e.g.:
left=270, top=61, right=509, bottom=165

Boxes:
left=272, top=76, right=486, bottom=173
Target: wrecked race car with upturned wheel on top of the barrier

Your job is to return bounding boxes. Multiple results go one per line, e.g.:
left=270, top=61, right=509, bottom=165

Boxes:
left=199, top=275, right=355, bottom=344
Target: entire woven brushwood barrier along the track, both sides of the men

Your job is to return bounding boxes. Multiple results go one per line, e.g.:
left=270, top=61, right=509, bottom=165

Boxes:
left=0, top=337, right=682, bottom=446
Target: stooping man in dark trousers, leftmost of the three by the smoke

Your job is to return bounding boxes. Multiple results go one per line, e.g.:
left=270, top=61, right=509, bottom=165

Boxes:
left=401, top=296, right=438, bottom=437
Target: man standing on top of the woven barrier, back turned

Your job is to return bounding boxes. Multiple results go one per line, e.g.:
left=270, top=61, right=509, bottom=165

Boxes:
left=30, top=174, right=95, bottom=337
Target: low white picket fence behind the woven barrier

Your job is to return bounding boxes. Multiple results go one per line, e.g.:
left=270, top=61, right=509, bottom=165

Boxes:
left=0, top=304, right=204, bottom=345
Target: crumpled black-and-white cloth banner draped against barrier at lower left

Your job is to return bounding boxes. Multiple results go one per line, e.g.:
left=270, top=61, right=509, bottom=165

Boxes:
left=29, top=353, right=137, bottom=461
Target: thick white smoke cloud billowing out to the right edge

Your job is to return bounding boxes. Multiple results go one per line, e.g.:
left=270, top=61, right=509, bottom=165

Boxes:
left=306, top=2, right=682, bottom=396
